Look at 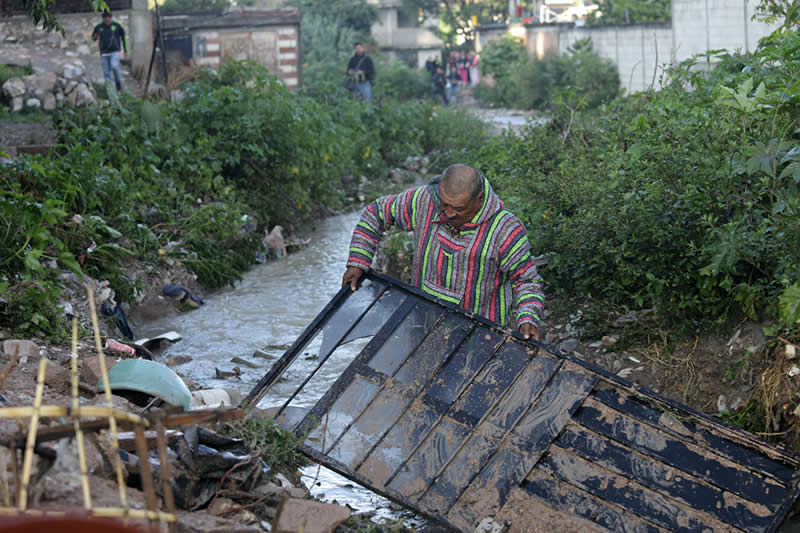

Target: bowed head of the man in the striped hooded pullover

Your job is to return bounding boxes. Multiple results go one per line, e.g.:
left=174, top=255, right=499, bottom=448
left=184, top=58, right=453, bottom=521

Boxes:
left=439, top=165, right=484, bottom=228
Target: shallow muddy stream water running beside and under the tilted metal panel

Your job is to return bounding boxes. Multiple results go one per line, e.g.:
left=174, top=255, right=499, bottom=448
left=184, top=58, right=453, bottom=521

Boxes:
left=136, top=214, right=432, bottom=525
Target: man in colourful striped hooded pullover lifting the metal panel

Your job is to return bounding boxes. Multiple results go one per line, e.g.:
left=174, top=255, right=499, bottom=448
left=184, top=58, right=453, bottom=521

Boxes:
left=342, top=165, right=544, bottom=340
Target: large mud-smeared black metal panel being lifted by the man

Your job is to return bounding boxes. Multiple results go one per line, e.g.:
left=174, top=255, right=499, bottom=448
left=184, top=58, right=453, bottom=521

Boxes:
left=245, top=273, right=800, bottom=532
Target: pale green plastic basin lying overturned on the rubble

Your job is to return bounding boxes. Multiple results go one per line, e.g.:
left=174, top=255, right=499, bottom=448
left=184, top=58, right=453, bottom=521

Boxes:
left=95, top=359, right=192, bottom=409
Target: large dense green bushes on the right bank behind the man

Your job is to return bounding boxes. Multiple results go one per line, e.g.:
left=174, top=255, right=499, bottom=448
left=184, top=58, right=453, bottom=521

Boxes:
left=466, top=27, right=800, bottom=327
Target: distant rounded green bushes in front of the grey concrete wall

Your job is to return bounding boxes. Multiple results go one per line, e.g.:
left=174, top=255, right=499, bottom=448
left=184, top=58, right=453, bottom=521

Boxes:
left=476, top=36, right=620, bottom=109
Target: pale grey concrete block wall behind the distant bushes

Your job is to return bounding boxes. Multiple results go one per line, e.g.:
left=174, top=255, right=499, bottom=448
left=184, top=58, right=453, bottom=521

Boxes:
left=478, top=0, right=777, bottom=92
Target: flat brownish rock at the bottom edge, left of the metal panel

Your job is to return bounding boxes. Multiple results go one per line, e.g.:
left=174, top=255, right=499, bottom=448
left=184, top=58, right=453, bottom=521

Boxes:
left=272, top=498, right=350, bottom=533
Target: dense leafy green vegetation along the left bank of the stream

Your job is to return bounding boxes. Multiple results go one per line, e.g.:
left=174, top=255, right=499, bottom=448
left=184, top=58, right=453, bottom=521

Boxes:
left=0, top=62, right=486, bottom=336
